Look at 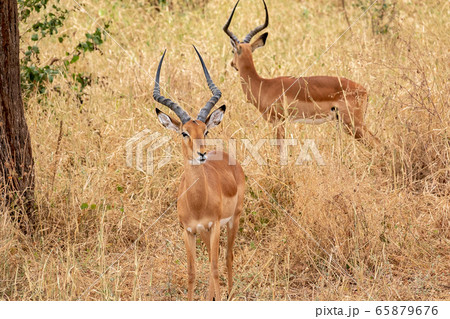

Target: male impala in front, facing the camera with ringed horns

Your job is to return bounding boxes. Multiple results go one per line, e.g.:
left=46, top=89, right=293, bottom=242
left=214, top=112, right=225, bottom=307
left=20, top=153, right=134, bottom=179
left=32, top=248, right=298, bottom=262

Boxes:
left=153, top=47, right=245, bottom=300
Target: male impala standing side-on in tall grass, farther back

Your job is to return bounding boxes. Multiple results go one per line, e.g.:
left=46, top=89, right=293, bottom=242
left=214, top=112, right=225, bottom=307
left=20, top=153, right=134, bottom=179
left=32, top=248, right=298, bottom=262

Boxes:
left=223, top=0, right=378, bottom=143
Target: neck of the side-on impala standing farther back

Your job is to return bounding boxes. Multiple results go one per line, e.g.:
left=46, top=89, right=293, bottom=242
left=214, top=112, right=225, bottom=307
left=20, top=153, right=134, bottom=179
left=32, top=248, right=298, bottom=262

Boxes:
left=238, top=53, right=263, bottom=108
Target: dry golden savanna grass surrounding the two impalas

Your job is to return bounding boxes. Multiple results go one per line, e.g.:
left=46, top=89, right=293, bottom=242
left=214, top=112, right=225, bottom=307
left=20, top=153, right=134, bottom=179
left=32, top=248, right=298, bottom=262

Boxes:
left=0, top=0, right=450, bottom=300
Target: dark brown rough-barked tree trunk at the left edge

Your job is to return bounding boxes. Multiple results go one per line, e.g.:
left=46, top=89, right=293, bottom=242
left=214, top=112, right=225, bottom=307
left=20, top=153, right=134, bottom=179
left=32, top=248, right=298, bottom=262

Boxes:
left=0, top=0, right=34, bottom=226
